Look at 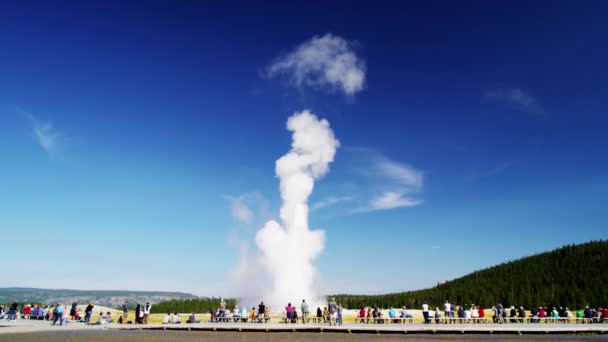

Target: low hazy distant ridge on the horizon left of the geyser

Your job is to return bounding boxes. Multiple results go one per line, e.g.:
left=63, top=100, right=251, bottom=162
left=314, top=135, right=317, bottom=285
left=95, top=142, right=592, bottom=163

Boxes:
left=0, top=287, right=199, bottom=308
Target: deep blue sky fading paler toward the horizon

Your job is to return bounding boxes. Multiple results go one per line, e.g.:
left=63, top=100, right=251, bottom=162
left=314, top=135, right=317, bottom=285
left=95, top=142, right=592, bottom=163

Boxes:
left=0, top=1, right=608, bottom=295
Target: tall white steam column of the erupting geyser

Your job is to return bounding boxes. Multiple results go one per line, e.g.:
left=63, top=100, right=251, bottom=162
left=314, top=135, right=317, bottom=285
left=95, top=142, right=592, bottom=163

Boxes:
left=256, top=110, right=340, bottom=308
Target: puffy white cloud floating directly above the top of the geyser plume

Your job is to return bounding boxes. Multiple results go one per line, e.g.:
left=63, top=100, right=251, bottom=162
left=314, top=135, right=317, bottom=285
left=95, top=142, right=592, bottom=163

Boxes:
left=267, top=33, right=366, bottom=96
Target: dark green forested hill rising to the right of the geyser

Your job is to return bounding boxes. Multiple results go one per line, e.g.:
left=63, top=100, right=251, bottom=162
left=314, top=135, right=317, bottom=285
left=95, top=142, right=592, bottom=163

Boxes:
left=335, top=241, right=608, bottom=309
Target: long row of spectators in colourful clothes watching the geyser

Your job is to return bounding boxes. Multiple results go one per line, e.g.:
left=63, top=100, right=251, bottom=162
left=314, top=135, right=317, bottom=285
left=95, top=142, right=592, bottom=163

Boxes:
left=0, top=298, right=608, bottom=326
